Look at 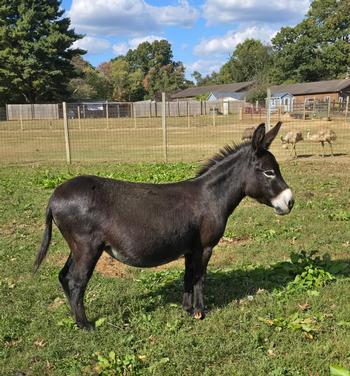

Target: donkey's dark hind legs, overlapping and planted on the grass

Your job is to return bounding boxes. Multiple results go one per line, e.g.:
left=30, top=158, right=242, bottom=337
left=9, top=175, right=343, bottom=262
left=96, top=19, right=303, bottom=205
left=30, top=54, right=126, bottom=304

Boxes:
left=59, top=241, right=102, bottom=329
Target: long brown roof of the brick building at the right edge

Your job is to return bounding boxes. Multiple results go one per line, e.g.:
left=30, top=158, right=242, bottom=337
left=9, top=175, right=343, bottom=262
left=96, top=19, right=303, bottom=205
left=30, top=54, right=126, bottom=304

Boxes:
left=271, top=79, right=350, bottom=95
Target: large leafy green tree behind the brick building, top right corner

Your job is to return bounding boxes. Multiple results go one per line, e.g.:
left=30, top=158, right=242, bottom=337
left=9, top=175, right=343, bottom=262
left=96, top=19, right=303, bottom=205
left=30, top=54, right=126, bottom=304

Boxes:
left=272, top=0, right=350, bottom=83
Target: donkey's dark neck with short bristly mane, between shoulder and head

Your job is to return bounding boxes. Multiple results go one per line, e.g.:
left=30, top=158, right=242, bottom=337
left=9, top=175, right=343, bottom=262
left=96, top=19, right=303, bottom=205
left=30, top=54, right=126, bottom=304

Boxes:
left=197, top=148, right=249, bottom=217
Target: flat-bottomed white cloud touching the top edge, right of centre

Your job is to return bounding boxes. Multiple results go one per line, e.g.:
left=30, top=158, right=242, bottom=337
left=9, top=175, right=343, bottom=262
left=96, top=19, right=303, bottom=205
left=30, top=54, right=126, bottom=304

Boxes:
left=203, top=0, right=310, bottom=24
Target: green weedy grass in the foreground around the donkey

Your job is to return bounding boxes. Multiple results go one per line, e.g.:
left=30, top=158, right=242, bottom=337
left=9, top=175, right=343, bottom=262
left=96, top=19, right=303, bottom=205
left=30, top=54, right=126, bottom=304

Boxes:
left=0, top=158, right=350, bottom=376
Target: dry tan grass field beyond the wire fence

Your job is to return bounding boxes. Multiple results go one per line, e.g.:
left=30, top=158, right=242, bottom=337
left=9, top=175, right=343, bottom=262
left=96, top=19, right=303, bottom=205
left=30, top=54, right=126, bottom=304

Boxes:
left=0, top=115, right=350, bottom=163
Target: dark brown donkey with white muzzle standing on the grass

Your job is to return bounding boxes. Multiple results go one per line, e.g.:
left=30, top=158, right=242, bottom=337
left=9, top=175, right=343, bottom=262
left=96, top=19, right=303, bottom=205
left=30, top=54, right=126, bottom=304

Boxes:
left=34, top=122, right=294, bottom=329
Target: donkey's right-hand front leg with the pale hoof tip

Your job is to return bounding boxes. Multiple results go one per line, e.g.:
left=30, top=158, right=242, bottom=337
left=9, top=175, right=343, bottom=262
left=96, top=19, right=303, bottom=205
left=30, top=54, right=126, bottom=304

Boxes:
left=193, top=247, right=212, bottom=319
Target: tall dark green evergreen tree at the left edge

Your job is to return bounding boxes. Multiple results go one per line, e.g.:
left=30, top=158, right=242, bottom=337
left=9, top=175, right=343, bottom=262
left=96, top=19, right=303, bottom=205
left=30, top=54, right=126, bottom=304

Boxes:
left=0, top=0, right=85, bottom=103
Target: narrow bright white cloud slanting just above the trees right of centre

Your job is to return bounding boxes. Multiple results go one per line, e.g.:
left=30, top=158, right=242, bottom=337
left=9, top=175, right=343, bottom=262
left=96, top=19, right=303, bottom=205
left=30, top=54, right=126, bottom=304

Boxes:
left=194, top=26, right=277, bottom=56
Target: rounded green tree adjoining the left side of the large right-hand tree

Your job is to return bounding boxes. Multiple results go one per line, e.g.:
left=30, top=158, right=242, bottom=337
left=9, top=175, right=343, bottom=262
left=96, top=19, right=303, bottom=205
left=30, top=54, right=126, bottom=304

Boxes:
left=219, top=39, right=272, bottom=83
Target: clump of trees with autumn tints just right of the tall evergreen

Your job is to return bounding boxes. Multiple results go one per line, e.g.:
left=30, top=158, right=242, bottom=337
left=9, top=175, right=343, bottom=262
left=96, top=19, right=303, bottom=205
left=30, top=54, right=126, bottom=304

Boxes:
left=70, top=40, right=193, bottom=101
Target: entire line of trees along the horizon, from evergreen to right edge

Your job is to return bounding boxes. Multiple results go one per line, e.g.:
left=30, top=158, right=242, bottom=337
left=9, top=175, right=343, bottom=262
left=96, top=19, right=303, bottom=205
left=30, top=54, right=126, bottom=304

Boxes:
left=0, top=0, right=350, bottom=104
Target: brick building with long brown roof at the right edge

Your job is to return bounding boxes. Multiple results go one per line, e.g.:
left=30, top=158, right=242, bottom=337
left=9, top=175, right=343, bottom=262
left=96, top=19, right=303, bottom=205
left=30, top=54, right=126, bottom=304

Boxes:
left=271, top=79, right=350, bottom=103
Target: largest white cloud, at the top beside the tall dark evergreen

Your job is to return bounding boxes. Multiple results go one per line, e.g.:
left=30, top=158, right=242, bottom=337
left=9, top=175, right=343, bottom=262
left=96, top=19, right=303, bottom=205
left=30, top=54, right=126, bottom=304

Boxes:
left=68, top=0, right=198, bottom=36
